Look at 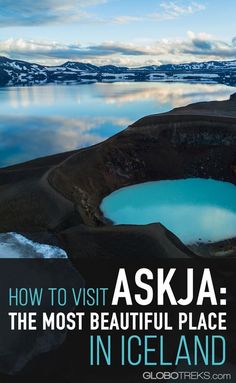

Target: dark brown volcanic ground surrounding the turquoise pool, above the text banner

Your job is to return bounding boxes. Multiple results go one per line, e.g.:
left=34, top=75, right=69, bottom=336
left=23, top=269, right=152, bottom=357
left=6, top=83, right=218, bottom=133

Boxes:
left=0, top=94, right=236, bottom=258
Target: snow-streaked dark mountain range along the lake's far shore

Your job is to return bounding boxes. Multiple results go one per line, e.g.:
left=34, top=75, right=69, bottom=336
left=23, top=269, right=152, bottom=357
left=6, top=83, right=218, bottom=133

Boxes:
left=0, top=57, right=236, bottom=86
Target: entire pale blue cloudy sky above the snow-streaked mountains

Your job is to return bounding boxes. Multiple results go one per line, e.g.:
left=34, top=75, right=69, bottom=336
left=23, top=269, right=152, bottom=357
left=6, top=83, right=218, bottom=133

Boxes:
left=0, top=0, right=236, bottom=67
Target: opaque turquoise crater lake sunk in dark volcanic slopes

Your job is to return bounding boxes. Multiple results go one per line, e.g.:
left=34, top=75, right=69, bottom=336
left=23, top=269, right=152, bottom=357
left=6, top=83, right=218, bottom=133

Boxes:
left=100, top=178, right=236, bottom=244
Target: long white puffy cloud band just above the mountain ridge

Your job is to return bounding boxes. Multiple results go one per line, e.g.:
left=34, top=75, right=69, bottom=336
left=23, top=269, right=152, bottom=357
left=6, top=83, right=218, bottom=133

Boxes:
left=0, top=32, right=236, bottom=66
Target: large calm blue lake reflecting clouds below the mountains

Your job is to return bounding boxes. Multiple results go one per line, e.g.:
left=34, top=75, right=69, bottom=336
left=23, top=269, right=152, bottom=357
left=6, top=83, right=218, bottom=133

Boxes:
left=0, top=83, right=235, bottom=167
